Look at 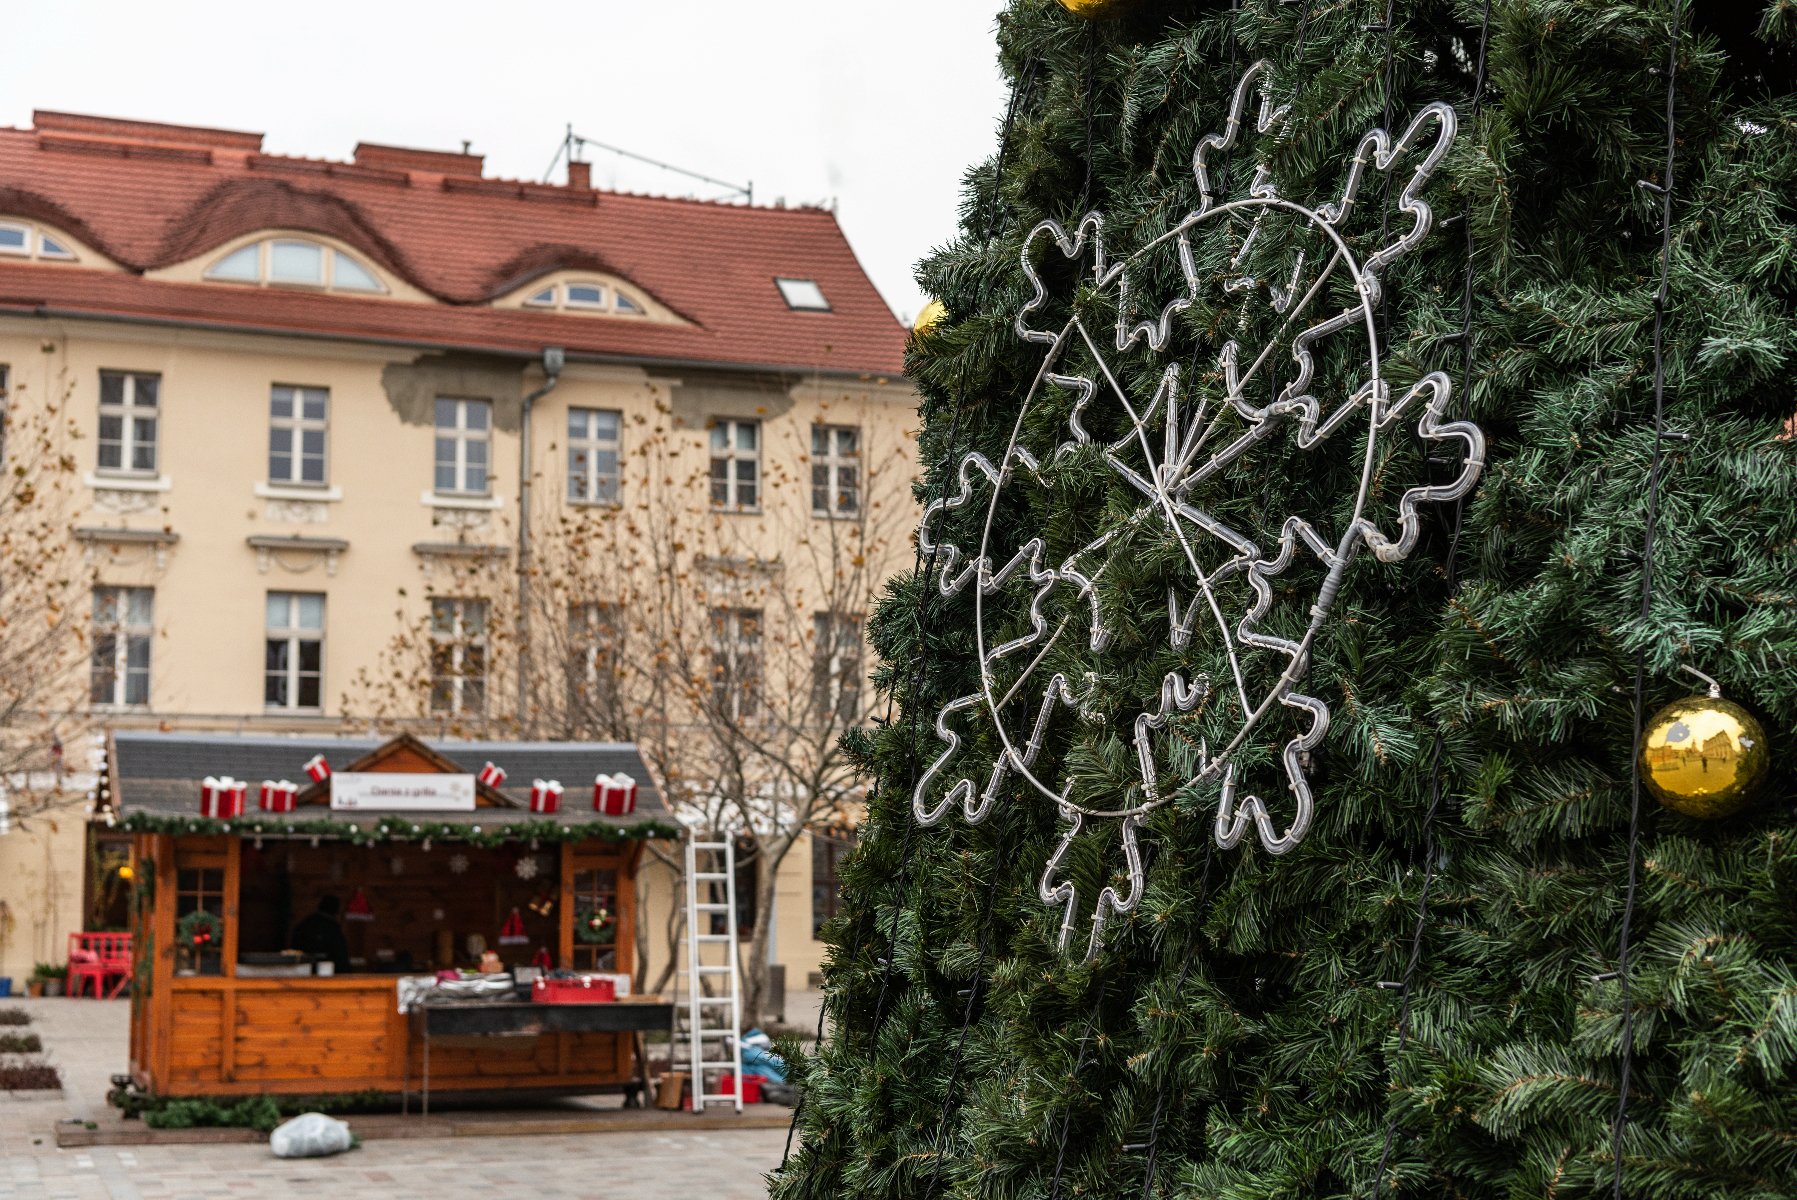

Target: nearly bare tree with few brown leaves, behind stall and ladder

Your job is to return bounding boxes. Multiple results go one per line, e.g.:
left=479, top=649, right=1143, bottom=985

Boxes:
left=345, top=389, right=913, bottom=1022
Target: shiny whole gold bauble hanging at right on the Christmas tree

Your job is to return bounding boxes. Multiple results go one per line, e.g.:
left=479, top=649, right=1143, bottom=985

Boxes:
left=1639, top=695, right=1766, bottom=821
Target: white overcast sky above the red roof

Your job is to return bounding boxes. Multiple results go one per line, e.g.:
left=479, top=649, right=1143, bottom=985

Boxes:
left=0, top=0, right=1005, bottom=320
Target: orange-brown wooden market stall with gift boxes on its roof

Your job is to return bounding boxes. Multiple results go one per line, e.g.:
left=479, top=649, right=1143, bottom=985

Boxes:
left=108, top=731, right=674, bottom=1096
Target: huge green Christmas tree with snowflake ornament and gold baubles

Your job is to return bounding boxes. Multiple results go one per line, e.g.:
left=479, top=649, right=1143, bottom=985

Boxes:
left=773, top=0, right=1797, bottom=1200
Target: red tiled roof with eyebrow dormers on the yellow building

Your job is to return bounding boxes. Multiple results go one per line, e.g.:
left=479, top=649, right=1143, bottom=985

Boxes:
left=0, top=111, right=906, bottom=375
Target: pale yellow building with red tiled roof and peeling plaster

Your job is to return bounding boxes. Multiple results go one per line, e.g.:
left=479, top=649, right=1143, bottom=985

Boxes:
left=0, top=113, right=916, bottom=1013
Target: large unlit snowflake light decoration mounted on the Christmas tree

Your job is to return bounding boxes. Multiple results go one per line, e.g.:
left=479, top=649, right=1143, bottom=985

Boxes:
left=913, top=61, right=1484, bottom=957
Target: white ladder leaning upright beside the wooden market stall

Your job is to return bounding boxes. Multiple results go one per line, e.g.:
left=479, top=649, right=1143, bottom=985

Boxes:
left=670, top=832, right=742, bottom=1114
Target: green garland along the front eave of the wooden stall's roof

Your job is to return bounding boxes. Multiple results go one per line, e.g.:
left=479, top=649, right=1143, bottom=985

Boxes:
left=120, top=812, right=683, bottom=850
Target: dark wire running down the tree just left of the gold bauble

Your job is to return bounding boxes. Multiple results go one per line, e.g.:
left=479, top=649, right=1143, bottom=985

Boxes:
left=1610, top=0, right=1682, bottom=1200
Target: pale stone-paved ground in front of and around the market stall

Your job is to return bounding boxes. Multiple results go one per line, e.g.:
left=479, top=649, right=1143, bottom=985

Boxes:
left=0, top=999, right=785, bottom=1200
